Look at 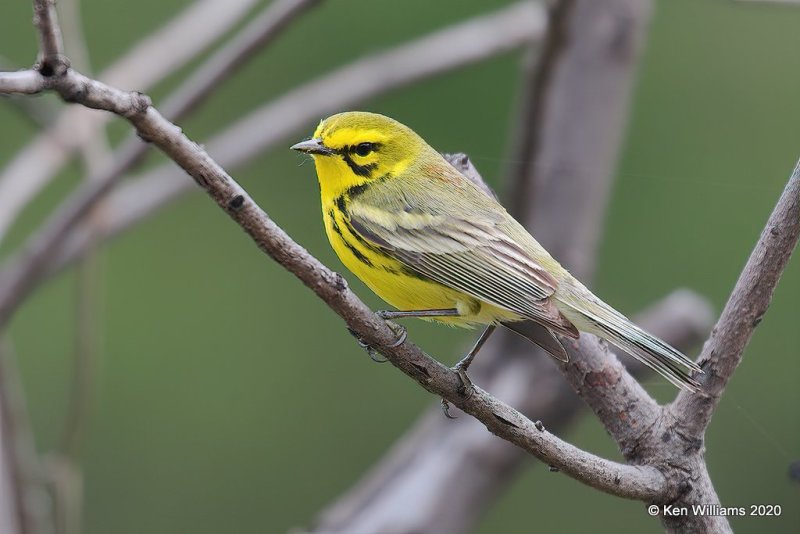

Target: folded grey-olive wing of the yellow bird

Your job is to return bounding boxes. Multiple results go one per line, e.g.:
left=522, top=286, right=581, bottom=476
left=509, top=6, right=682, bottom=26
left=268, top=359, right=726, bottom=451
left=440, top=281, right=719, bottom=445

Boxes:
left=347, top=173, right=578, bottom=337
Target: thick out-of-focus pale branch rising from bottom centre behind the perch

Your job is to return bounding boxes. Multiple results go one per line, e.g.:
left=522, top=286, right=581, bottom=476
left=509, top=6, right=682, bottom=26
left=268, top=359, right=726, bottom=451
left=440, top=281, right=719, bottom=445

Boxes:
left=311, top=290, right=713, bottom=532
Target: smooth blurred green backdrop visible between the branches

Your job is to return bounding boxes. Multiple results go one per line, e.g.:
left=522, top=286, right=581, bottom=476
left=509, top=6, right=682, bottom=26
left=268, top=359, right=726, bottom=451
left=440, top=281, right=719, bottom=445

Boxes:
left=0, top=0, right=800, bottom=534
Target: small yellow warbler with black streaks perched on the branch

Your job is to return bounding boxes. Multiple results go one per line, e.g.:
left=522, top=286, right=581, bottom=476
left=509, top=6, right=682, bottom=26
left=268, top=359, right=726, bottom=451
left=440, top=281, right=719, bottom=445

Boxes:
left=291, top=111, right=702, bottom=392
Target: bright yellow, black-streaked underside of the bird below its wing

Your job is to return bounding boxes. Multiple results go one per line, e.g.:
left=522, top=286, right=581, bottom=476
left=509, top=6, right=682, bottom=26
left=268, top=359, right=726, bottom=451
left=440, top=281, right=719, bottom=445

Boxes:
left=325, top=208, right=520, bottom=327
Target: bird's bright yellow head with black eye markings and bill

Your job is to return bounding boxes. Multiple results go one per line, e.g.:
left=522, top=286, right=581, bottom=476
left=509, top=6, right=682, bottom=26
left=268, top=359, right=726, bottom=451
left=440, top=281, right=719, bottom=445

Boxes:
left=292, top=112, right=425, bottom=198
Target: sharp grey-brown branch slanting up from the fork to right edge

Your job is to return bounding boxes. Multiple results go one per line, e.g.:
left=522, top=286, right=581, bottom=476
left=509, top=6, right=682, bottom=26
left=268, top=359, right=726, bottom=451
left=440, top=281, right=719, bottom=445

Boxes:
left=670, top=161, right=800, bottom=437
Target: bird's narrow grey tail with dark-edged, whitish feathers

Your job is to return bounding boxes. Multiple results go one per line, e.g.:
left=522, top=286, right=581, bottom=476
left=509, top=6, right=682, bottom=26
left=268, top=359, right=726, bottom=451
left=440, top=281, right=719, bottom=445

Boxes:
left=559, top=287, right=703, bottom=392
